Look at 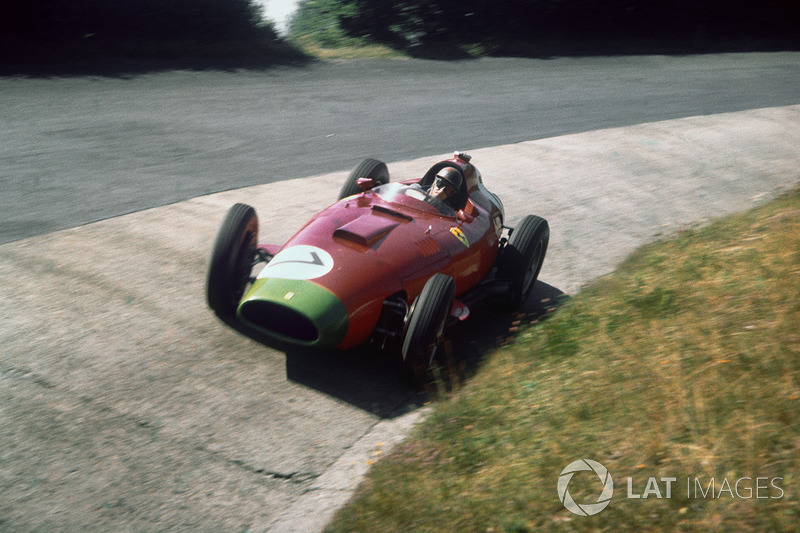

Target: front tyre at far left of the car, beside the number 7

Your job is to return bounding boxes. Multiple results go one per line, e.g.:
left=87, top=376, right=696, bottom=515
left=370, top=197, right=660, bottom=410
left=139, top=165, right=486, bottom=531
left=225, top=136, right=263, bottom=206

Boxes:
left=206, top=204, right=258, bottom=316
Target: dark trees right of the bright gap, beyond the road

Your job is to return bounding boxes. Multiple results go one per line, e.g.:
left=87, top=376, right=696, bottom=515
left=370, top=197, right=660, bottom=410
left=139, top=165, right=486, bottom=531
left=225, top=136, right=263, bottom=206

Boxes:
left=299, top=0, right=800, bottom=53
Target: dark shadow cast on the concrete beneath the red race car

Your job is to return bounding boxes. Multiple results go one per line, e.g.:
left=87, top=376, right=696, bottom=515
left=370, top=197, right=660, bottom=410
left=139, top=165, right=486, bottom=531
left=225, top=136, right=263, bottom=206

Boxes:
left=219, top=281, right=567, bottom=418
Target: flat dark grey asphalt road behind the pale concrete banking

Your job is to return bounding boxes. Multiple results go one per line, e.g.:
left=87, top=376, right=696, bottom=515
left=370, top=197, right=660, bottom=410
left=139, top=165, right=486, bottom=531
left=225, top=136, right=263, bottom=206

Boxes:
left=0, top=53, right=800, bottom=243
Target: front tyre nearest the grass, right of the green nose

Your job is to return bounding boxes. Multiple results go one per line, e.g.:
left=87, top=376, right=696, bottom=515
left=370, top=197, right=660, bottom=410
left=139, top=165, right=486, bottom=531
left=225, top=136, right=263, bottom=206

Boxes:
left=402, top=273, right=456, bottom=385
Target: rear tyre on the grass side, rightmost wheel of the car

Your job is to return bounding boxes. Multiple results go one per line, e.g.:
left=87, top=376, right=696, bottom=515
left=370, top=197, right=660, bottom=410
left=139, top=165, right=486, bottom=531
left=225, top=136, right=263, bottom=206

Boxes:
left=498, top=215, right=550, bottom=309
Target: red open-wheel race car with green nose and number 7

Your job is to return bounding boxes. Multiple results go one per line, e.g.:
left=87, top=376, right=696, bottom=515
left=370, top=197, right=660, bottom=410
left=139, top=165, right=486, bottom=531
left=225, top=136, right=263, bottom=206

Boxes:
left=206, top=152, right=550, bottom=379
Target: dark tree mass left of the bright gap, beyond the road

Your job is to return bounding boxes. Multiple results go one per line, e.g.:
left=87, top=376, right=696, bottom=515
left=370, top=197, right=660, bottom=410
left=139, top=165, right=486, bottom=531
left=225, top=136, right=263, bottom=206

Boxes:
left=0, top=0, right=304, bottom=71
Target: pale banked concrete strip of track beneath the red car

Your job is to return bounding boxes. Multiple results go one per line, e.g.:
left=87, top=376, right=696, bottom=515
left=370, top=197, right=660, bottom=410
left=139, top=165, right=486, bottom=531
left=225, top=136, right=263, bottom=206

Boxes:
left=0, top=106, right=800, bottom=531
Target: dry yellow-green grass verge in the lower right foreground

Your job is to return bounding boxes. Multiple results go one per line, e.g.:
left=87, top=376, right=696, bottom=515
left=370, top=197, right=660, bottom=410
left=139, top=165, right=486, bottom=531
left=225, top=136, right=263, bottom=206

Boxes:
left=329, top=190, right=800, bottom=532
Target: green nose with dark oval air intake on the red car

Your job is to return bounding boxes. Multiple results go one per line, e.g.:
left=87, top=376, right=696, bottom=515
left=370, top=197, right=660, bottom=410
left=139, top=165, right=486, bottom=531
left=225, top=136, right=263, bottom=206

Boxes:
left=237, top=278, right=349, bottom=348
